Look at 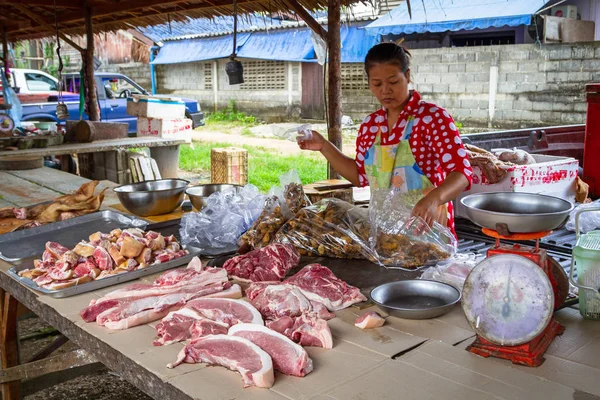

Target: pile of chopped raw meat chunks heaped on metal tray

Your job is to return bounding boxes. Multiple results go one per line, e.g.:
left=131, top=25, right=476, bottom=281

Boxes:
left=19, top=228, right=188, bottom=290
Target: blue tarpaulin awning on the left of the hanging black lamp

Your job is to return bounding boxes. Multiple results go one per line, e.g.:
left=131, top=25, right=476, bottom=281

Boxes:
left=152, top=33, right=250, bottom=64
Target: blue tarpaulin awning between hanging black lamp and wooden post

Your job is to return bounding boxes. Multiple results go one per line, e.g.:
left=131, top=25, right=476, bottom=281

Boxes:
left=238, top=28, right=315, bottom=61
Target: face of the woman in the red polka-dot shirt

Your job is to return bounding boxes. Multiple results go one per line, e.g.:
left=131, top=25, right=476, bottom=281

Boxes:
left=369, top=64, right=410, bottom=109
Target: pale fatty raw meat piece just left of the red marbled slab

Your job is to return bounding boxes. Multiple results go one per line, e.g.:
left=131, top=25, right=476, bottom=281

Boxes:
left=246, top=285, right=335, bottom=320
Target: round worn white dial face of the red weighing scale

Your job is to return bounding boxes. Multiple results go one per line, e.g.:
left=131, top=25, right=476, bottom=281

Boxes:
left=462, top=254, right=554, bottom=346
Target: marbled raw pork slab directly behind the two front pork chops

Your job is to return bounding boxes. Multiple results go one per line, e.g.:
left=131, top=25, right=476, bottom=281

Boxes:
left=154, top=297, right=264, bottom=346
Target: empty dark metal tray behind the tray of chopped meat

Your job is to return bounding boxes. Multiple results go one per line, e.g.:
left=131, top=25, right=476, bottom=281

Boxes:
left=0, top=210, right=148, bottom=264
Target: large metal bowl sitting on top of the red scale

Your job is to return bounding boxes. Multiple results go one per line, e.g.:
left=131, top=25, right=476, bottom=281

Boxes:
left=461, top=192, right=573, bottom=233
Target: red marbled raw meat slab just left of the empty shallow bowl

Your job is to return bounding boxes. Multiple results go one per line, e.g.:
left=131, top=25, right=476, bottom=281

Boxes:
left=284, top=264, right=367, bottom=311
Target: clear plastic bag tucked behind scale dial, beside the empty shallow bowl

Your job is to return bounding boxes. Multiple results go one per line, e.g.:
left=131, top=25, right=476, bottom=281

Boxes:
left=417, top=253, right=485, bottom=291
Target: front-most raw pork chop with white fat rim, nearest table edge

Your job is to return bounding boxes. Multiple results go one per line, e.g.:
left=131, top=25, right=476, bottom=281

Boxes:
left=167, top=335, right=275, bottom=388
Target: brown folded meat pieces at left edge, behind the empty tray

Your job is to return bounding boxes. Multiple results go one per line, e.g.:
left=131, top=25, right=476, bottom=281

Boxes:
left=0, top=181, right=106, bottom=234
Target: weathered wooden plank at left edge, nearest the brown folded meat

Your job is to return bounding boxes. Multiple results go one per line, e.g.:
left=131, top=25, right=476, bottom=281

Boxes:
left=0, top=172, right=62, bottom=207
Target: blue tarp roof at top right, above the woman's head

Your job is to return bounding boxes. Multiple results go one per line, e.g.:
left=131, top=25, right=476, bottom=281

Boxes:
left=365, top=0, right=549, bottom=35
